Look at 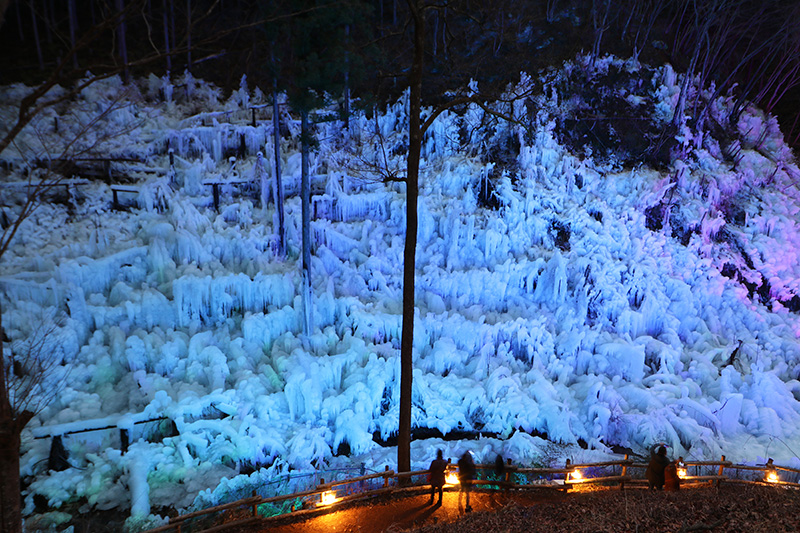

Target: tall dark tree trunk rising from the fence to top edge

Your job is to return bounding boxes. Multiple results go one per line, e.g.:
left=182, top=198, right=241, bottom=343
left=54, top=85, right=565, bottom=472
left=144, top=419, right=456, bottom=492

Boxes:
left=397, top=0, right=425, bottom=472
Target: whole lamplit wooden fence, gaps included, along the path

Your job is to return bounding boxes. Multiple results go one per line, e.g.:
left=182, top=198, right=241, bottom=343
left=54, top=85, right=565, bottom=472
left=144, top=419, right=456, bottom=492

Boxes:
left=145, top=455, right=800, bottom=533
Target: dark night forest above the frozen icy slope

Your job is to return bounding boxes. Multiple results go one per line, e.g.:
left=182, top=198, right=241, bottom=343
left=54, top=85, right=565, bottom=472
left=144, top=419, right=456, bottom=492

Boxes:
left=0, top=0, right=800, bottom=147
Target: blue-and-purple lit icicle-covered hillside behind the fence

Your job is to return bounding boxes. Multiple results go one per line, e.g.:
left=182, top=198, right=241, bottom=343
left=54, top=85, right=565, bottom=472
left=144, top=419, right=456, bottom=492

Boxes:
left=0, top=58, right=800, bottom=528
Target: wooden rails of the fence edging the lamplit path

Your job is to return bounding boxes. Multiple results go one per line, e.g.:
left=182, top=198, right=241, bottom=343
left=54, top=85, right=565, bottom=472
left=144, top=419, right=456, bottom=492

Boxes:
left=145, top=456, right=800, bottom=533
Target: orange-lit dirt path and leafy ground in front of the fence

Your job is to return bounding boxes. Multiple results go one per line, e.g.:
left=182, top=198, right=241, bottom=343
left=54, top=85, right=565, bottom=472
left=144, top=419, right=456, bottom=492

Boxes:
left=229, top=483, right=800, bottom=533
